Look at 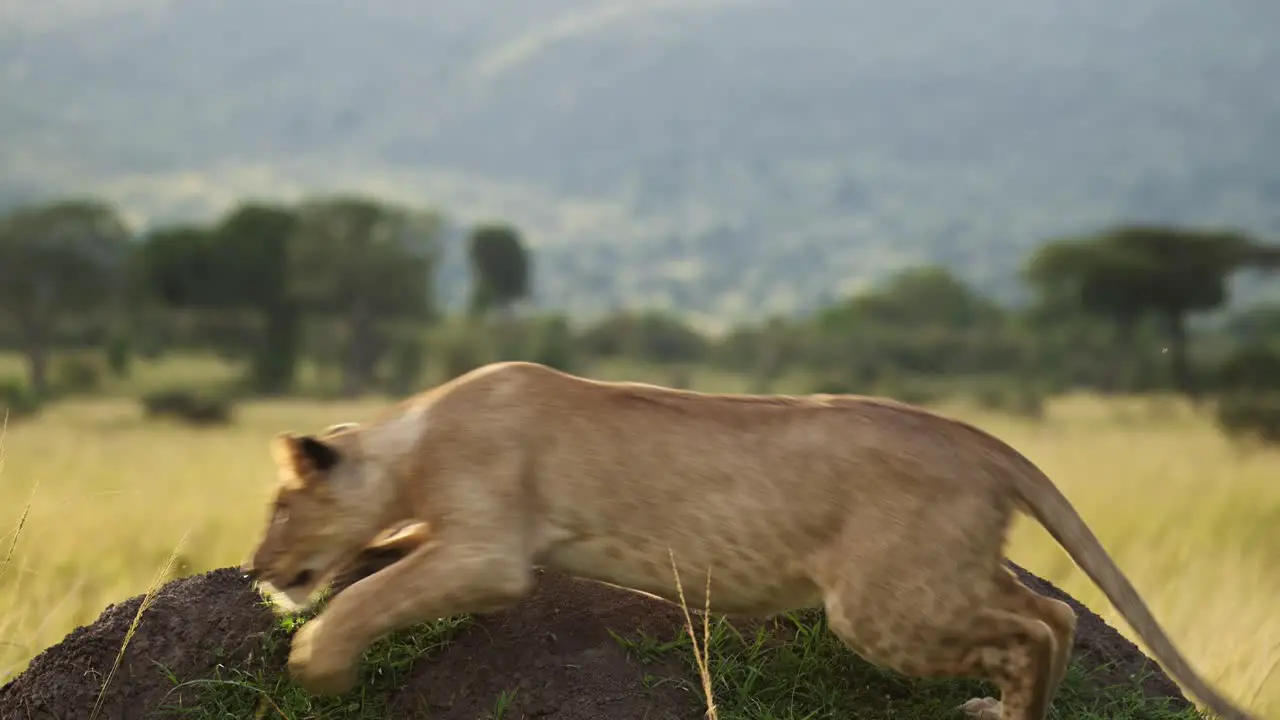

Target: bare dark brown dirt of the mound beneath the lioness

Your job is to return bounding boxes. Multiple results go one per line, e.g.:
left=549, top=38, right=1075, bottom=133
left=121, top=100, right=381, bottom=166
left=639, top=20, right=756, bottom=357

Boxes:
left=0, top=566, right=1187, bottom=720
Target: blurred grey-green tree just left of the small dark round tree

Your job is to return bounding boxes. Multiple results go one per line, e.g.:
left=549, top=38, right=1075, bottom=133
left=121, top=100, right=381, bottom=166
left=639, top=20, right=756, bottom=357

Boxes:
left=289, top=195, right=442, bottom=396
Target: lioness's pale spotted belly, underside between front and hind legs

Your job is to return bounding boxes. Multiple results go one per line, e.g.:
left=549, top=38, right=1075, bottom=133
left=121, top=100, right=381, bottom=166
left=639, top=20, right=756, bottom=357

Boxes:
left=536, top=530, right=822, bottom=615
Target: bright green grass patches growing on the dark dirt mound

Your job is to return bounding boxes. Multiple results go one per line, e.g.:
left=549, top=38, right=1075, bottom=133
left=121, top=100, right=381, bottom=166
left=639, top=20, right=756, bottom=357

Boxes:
left=162, top=597, right=1202, bottom=720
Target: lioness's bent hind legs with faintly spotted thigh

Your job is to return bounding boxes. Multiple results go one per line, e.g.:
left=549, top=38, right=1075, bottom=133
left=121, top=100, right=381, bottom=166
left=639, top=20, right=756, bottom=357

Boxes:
left=815, top=546, right=1074, bottom=720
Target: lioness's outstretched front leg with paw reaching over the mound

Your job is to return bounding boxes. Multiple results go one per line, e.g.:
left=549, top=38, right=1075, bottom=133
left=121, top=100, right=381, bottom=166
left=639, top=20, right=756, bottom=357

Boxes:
left=289, top=541, right=534, bottom=694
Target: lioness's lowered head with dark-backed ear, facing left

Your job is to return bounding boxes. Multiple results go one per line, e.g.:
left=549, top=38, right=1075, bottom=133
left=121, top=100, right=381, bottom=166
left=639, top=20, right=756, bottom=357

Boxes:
left=241, top=425, right=387, bottom=611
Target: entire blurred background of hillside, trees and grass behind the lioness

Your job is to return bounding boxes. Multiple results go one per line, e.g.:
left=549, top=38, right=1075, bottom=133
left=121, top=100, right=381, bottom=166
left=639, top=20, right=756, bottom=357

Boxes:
left=0, top=0, right=1280, bottom=710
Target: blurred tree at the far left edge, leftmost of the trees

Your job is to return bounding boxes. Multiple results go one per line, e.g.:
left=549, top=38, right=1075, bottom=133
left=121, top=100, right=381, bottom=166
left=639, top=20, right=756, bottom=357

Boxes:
left=0, top=199, right=132, bottom=395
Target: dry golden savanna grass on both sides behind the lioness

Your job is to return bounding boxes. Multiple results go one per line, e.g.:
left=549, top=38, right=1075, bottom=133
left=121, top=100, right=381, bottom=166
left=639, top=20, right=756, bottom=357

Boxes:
left=0, top=360, right=1280, bottom=717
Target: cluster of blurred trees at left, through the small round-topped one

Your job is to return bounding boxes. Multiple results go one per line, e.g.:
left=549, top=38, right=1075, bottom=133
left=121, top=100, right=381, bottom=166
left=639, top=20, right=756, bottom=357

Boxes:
left=0, top=195, right=529, bottom=395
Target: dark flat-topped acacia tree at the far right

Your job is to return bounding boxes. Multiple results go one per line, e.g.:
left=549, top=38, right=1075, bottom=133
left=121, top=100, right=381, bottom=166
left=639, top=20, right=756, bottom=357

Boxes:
left=1024, top=225, right=1280, bottom=396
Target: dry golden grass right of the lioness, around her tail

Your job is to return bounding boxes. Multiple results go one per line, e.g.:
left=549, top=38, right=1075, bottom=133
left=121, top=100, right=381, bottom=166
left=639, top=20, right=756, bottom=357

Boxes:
left=956, top=397, right=1280, bottom=717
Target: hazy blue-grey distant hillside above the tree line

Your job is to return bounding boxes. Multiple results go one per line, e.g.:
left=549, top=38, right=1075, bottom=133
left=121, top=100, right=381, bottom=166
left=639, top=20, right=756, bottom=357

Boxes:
left=0, top=0, right=1280, bottom=318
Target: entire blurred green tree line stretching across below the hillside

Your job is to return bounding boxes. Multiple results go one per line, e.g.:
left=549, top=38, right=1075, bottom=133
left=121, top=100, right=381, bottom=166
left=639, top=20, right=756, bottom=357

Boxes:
left=0, top=195, right=1280, bottom=412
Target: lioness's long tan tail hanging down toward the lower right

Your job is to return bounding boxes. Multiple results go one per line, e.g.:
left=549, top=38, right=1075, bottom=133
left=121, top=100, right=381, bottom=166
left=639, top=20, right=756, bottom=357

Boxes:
left=1012, top=451, right=1258, bottom=720
